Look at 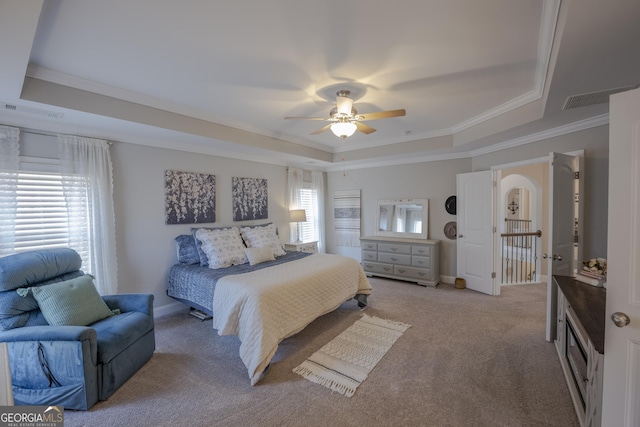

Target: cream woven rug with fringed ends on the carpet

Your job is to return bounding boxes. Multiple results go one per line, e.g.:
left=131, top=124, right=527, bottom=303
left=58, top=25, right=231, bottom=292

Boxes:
left=293, top=314, right=411, bottom=397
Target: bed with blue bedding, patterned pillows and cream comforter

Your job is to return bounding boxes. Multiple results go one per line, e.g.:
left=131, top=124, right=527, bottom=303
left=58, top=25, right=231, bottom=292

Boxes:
left=167, top=226, right=371, bottom=385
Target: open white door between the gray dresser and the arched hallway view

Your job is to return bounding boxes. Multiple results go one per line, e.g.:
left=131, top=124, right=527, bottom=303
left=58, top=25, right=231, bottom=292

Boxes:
left=457, top=171, right=494, bottom=295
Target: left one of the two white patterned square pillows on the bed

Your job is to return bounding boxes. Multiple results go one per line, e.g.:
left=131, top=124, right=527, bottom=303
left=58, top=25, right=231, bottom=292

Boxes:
left=196, top=227, right=247, bottom=269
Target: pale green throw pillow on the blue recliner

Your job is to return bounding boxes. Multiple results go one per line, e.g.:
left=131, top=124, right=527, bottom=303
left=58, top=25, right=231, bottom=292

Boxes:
left=31, top=274, right=113, bottom=326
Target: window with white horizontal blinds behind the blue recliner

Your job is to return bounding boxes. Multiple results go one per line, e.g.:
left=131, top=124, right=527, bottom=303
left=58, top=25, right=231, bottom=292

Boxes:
left=0, top=172, right=90, bottom=267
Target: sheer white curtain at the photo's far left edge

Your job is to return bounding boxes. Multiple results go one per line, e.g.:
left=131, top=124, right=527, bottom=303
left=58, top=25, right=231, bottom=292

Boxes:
left=0, top=126, right=20, bottom=256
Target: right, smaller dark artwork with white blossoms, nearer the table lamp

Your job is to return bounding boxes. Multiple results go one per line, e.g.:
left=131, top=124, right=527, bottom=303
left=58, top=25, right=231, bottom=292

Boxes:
left=231, top=177, right=269, bottom=221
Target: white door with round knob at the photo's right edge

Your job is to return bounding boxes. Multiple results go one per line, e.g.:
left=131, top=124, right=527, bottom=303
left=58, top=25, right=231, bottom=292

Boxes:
left=602, top=89, right=640, bottom=426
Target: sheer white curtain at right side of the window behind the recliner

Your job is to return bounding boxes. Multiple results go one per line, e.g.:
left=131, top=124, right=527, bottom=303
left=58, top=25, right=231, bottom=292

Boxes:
left=58, top=135, right=118, bottom=295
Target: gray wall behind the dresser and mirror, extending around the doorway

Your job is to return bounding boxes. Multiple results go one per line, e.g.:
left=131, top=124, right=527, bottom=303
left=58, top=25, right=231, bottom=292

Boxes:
left=326, top=126, right=609, bottom=277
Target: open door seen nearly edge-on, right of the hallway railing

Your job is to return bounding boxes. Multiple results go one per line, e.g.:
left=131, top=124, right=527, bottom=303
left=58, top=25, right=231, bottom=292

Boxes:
left=543, top=153, right=575, bottom=342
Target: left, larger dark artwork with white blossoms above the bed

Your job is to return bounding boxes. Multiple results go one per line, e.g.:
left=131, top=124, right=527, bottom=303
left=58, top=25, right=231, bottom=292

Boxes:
left=164, top=170, right=216, bottom=224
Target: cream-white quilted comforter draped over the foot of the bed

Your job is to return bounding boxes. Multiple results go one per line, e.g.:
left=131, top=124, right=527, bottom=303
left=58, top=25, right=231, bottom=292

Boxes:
left=213, top=254, right=371, bottom=385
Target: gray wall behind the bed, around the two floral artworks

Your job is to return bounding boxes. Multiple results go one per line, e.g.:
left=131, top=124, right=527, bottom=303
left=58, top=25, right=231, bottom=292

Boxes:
left=111, top=143, right=289, bottom=307
